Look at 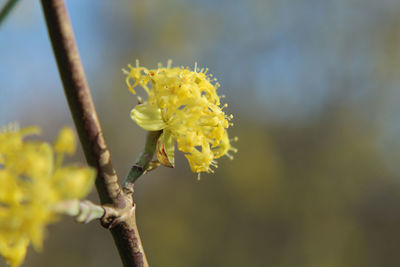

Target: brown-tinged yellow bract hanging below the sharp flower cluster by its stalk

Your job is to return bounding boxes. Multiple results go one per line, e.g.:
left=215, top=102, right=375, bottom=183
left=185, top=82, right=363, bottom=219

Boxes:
left=156, top=131, right=175, bottom=168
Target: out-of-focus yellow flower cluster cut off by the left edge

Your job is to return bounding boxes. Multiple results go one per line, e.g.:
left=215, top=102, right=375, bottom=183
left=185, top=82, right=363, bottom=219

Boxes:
left=0, top=126, right=95, bottom=266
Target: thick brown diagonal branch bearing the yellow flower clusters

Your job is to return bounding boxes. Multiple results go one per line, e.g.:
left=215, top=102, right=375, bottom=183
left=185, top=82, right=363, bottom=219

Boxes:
left=41, top=0, right=148, bottom=266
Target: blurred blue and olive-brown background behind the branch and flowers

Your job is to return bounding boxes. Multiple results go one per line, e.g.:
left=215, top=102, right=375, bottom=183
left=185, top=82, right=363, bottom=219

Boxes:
left=0, top=0, right=400, bottom=267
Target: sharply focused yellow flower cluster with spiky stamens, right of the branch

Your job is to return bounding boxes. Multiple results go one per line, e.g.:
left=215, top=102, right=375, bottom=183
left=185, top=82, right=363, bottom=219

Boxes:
left=125, top=62, right=236, bottom=173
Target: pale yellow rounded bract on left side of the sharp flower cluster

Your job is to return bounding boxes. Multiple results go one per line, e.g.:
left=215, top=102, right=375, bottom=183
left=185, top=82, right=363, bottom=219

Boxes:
left=131, top=103, right=167, bottom=131
